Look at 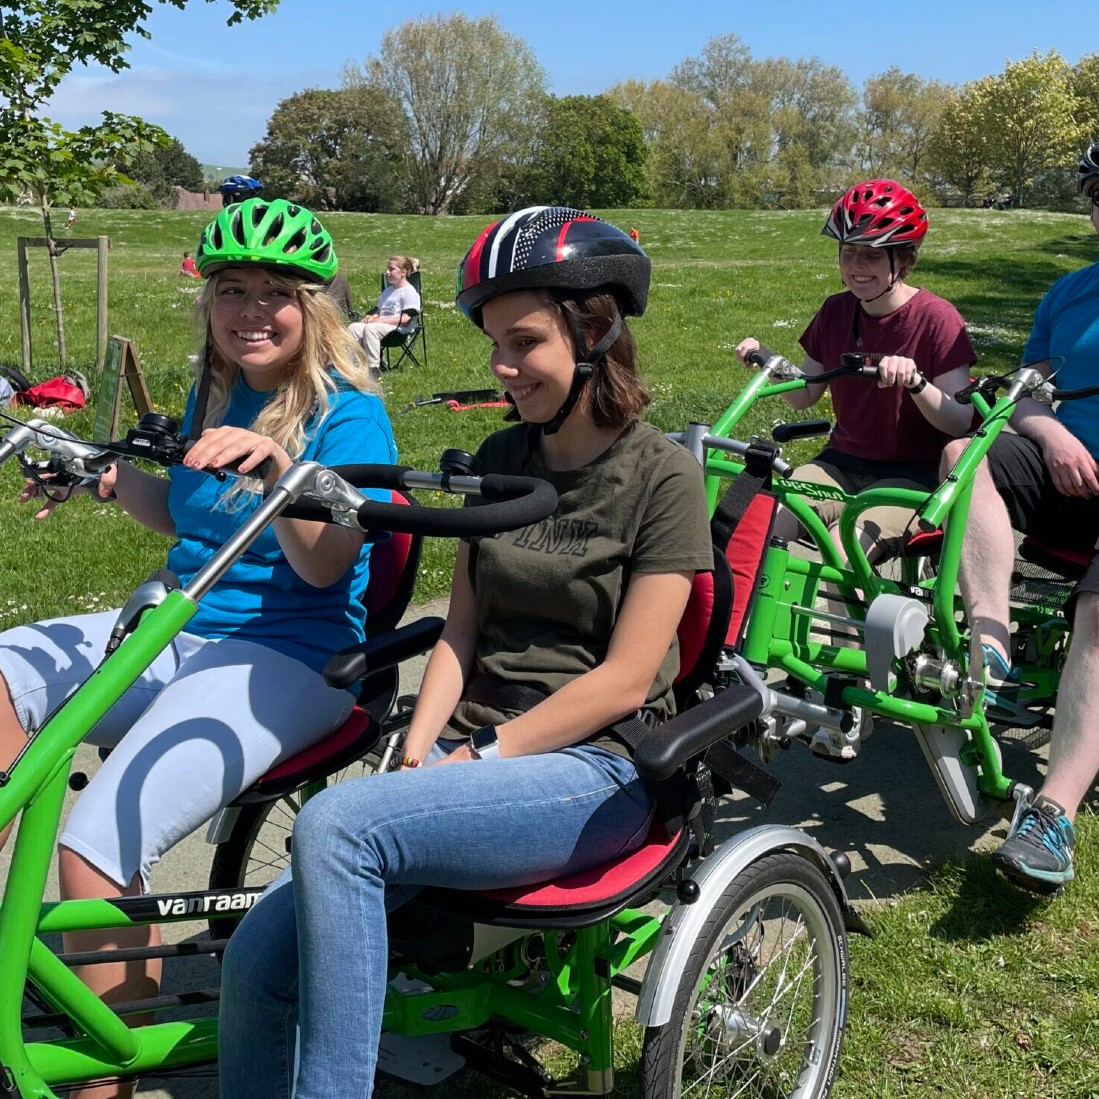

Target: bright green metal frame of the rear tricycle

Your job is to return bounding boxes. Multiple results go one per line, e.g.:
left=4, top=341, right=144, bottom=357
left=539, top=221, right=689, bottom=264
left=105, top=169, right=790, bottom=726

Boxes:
left=703, top=371, right=1052, bottom=800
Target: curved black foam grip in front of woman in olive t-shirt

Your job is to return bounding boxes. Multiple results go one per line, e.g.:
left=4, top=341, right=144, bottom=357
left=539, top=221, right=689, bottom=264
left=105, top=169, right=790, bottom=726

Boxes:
left=357, top=474, right=557, bottom=539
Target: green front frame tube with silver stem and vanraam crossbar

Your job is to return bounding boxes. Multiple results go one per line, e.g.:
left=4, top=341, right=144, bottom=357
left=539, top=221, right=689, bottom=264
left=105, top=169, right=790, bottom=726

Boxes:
left=0, top=463, right=322, bottom=1097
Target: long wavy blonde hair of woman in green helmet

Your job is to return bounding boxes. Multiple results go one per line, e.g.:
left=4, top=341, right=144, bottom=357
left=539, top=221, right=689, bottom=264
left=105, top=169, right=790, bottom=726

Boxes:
left=195, top=268, right=380, bottom=458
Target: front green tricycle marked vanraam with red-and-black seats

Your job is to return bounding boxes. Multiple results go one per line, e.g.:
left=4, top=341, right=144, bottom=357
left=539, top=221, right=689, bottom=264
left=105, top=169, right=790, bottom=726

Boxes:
left=0, top=418, right=863, bottom=1099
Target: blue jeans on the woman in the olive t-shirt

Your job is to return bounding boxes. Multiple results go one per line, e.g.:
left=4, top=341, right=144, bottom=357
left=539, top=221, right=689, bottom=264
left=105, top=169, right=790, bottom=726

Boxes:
left=219, top=745, right=653, bottom=1099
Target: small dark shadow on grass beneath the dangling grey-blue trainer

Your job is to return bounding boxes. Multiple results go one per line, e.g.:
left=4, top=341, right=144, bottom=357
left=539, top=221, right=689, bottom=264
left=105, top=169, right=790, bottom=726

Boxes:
left=926, top=856, right=1046, bottom=943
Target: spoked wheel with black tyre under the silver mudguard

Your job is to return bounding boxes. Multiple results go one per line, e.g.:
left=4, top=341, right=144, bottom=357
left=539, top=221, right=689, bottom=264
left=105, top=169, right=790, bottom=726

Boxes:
left=641, top=852, right=847, bottom=1099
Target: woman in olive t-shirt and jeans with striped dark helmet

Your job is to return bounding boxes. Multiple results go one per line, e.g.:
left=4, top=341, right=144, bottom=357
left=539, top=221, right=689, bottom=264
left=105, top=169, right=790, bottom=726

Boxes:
left=219, top=207, right=712, bottom=1099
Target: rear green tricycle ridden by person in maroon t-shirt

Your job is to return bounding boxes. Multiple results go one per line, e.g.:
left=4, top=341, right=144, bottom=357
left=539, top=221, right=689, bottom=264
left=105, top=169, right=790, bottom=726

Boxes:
left=680, top=348, right=1099, bottom=824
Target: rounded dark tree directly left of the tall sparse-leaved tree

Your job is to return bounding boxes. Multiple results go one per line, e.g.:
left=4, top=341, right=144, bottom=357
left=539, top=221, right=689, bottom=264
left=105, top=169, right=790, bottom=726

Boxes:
left=249, top=84, right=407, bottom=213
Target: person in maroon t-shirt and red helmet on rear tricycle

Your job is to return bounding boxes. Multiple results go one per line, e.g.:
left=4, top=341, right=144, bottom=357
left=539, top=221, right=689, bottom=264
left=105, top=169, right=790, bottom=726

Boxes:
left=736, top=179, right=977, bottom=560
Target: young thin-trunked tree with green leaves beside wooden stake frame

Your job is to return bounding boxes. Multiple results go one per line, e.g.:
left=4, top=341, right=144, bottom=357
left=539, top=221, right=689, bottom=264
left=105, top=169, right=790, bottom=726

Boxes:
left=0, top=0, right=278, bottom=366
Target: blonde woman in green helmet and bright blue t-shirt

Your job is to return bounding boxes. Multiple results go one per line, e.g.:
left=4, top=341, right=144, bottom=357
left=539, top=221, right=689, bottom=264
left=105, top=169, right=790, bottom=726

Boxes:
left=0, top=199, right=396, bottom=1099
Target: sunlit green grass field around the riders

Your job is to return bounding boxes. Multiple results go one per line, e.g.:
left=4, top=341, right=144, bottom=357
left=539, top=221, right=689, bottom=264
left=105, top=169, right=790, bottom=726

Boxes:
left=0, top=208, right=1099, bottom=1099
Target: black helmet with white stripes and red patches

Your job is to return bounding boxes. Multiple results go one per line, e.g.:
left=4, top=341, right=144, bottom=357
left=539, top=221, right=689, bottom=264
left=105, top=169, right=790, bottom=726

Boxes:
left=457, top=207, right=651, bottom=328
